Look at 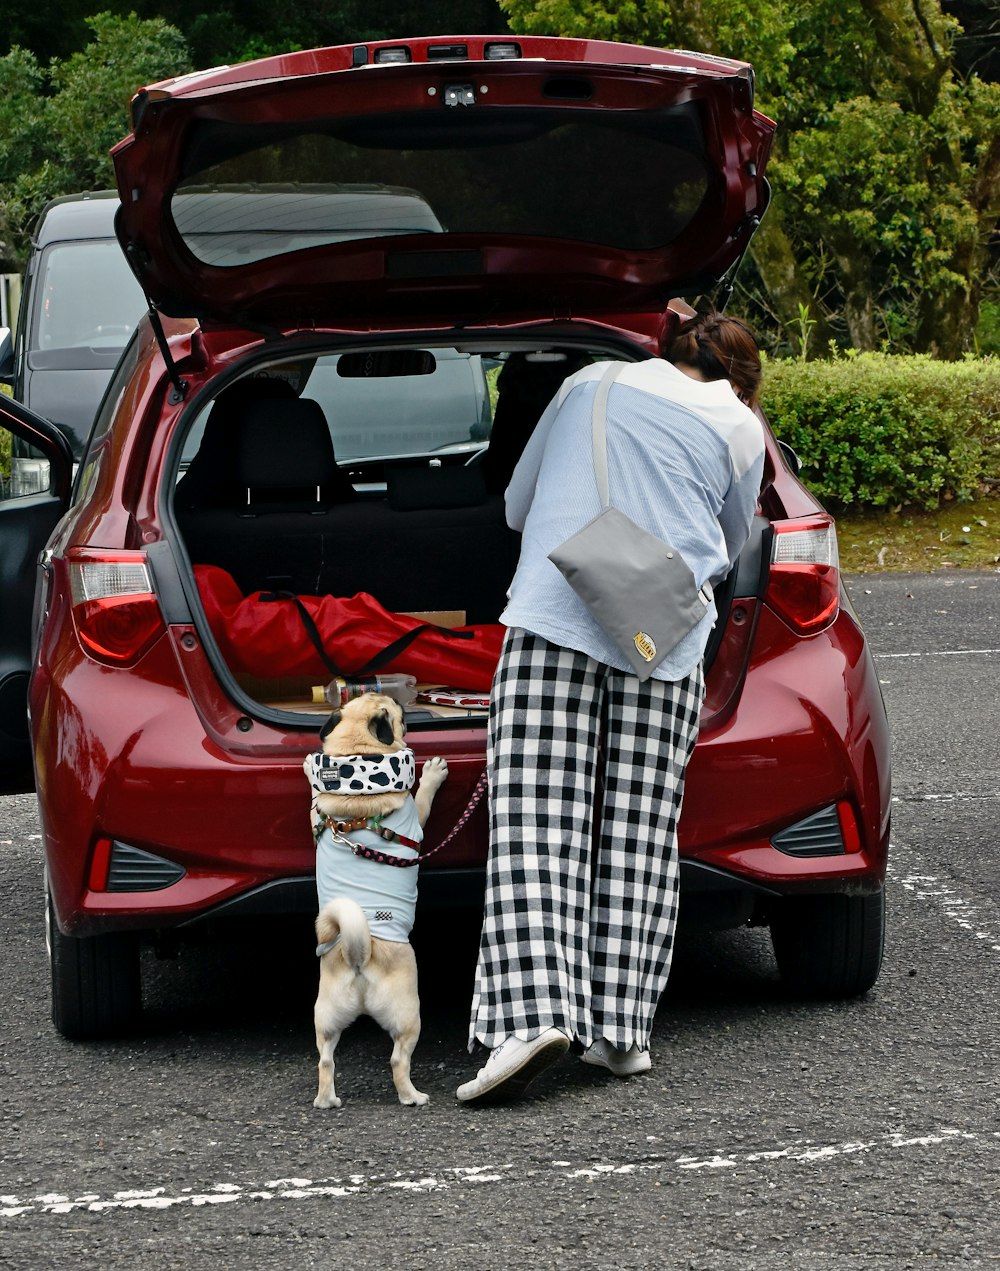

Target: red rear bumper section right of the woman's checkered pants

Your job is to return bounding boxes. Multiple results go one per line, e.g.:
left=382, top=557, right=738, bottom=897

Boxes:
left=680, top=608, right=891, bottom=894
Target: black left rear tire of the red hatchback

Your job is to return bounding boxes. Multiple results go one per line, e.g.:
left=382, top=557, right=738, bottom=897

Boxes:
left=46, top=897, right=142, bottom=1041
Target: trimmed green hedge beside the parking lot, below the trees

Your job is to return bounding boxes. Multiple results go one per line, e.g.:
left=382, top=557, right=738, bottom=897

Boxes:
left=761, top=353, right=1000, bottom=507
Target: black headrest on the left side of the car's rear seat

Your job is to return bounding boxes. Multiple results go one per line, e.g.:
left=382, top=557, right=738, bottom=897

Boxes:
left=236, top=398, right=338, bottom=492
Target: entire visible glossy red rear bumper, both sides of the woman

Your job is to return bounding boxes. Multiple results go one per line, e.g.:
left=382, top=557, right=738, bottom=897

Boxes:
left=32, top=541, right=888, bottom=934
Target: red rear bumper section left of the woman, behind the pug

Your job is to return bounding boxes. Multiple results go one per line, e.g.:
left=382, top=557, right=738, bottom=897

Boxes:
left=32, top=599, right=493, bottom=935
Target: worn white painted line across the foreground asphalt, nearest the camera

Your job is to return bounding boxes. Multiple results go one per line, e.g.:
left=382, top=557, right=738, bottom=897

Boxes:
left=0, top=1129, right=986, bottom=1219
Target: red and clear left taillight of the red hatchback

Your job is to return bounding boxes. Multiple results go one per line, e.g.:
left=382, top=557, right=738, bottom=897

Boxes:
left=66, top=548, right=166, bottom=666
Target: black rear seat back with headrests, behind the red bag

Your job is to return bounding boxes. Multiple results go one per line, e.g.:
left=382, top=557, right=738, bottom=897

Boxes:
left=177, top=400, right=520, bottom=623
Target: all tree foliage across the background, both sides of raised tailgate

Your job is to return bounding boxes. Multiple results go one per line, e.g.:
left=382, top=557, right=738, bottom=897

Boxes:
left=0, top=0, right=1000, bottom=357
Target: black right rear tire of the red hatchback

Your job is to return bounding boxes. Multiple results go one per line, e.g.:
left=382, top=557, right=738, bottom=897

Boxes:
left=770, top=890, right=886, bottom=998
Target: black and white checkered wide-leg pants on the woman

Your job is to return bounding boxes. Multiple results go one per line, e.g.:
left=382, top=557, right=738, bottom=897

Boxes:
left=469, top=629, right=704, bottom=1050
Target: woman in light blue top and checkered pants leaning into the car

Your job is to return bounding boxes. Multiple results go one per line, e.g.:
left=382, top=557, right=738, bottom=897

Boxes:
left=457, top=314, right=764, bottom=1103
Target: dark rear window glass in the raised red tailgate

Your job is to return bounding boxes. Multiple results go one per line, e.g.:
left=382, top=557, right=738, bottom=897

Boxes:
left=172, top=107, right=710, bottom=266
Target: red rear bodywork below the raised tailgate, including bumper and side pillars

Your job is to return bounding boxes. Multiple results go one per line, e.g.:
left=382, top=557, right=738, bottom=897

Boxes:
left=30, top=310, right=888, bottom=934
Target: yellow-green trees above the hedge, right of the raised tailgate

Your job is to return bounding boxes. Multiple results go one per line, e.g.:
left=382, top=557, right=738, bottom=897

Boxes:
left=502, top=0, right=1000, bottom=357
